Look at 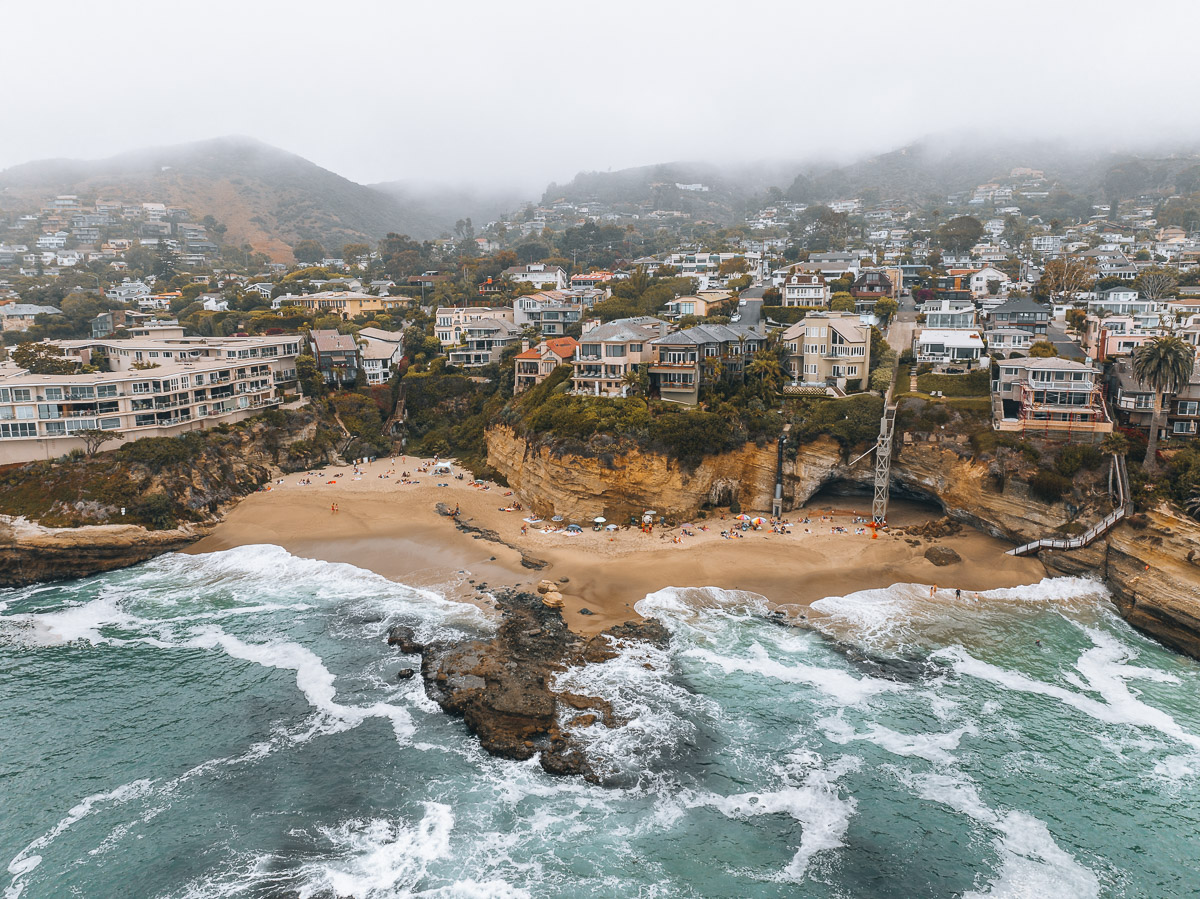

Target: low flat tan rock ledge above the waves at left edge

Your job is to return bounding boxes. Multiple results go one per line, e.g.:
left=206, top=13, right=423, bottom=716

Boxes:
left=0, top=516, right=210, bottom=587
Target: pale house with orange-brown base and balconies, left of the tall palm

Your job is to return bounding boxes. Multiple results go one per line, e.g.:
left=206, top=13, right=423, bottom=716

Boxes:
left=991, top=358, right=1112, bottom=443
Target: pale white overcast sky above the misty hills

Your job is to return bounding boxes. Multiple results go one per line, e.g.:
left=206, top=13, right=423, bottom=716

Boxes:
left=0, top=0, right=1200, bottom=188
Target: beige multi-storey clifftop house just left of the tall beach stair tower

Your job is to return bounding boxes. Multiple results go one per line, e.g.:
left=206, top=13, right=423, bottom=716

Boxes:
left=782, top=312, right=871, bottom=395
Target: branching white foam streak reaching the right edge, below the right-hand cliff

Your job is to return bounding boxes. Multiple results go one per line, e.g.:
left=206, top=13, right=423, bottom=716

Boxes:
left=934, top=628, right=1200, bottom=749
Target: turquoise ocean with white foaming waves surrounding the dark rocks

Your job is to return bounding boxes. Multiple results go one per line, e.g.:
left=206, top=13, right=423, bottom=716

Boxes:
left=0, top=546, right=1200, bottom=899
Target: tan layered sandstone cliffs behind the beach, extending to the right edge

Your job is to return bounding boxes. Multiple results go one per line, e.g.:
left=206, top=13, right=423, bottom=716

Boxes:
left=487, top=427, right=1200, bottom=659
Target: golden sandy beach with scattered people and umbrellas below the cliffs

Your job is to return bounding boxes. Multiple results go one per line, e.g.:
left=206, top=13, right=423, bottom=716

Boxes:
left=188, top=456, right=1044, bottom=634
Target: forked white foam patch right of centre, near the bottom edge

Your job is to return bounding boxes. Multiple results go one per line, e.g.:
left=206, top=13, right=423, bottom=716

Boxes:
left=692, top=750, right=860, bottom=883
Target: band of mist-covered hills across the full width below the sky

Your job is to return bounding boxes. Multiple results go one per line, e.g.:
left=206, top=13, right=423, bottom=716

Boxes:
left=0, top=137, right=1200, bottom=262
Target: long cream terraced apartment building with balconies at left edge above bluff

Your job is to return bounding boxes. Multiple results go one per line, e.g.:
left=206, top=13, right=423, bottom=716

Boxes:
left=0, top=335, right=301, bottom=465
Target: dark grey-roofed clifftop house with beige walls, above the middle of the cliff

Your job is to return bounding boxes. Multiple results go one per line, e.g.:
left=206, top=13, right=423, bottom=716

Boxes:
left=649, top=324, right=767, bottom=406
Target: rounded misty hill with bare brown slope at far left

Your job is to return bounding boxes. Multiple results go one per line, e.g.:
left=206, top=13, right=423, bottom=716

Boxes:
left=0, top=137, right=452, bottom=262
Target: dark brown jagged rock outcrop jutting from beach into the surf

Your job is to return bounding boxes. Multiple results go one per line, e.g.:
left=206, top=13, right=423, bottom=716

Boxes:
left=388, top=592, right=668, bottom=780
